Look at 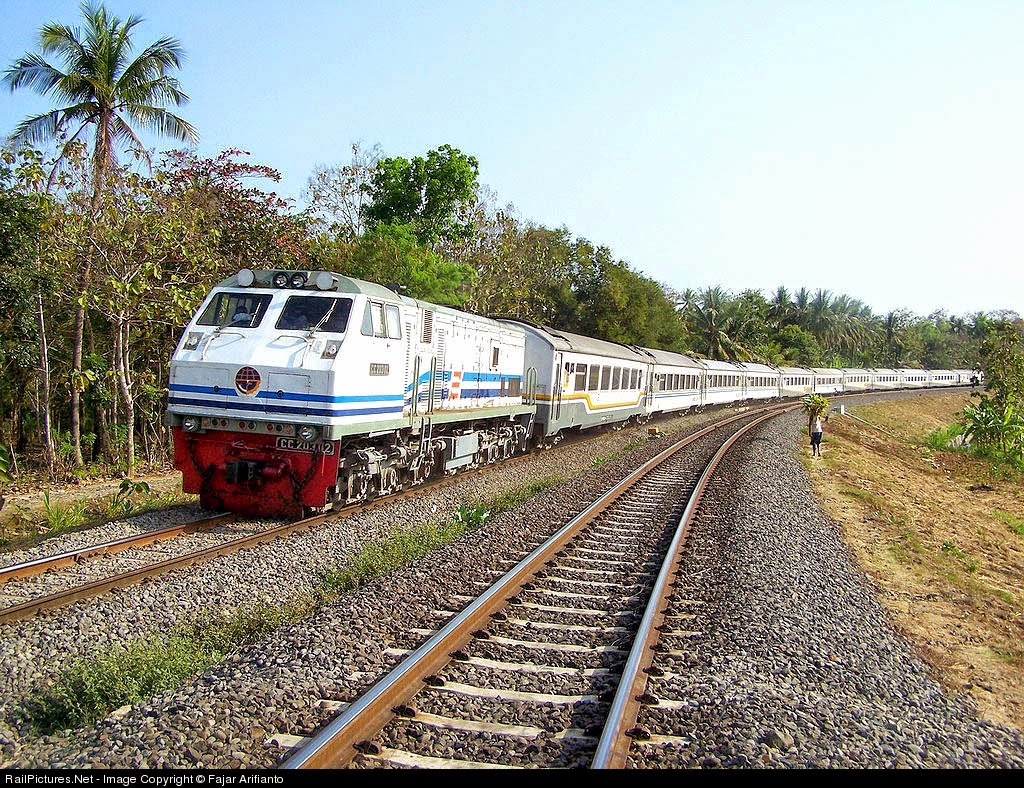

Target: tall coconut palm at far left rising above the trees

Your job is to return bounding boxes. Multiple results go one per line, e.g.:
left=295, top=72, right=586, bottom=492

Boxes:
left=3, top=2, right=199, bottom=467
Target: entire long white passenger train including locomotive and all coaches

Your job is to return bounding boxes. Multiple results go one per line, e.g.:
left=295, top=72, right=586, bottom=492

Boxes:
left=167, top=268, right=980, bottom=517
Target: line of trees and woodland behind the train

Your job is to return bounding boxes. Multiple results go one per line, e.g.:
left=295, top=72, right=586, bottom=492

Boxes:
left=0, top=143, right=1016, bottom=475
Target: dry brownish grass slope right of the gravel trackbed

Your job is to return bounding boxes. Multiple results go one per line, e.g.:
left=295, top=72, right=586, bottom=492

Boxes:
left=803, top=393, right=1024, bottom=729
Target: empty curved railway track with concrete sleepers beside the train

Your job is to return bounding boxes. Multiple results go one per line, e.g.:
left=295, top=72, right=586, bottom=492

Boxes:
left=274, top=404, right=797, bottom=769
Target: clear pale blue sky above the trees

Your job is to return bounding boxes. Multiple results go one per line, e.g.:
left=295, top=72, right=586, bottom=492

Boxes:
left=0, top=0, right=1024, bottom=315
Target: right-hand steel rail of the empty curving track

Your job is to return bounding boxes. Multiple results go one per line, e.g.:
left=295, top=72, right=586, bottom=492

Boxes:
left=591, top=405, right=799, bottom=769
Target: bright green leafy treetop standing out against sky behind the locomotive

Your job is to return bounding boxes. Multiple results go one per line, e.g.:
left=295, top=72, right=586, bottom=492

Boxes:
left=360, top=145, right=479, bottom=245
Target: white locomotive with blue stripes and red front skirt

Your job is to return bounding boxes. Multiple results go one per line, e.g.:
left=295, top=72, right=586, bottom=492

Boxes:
left=168, top=269, right=532, bottom=515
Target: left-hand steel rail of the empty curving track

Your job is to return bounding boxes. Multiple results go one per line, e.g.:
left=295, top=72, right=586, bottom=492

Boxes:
left=281, top=405, right=795, bottom=770
